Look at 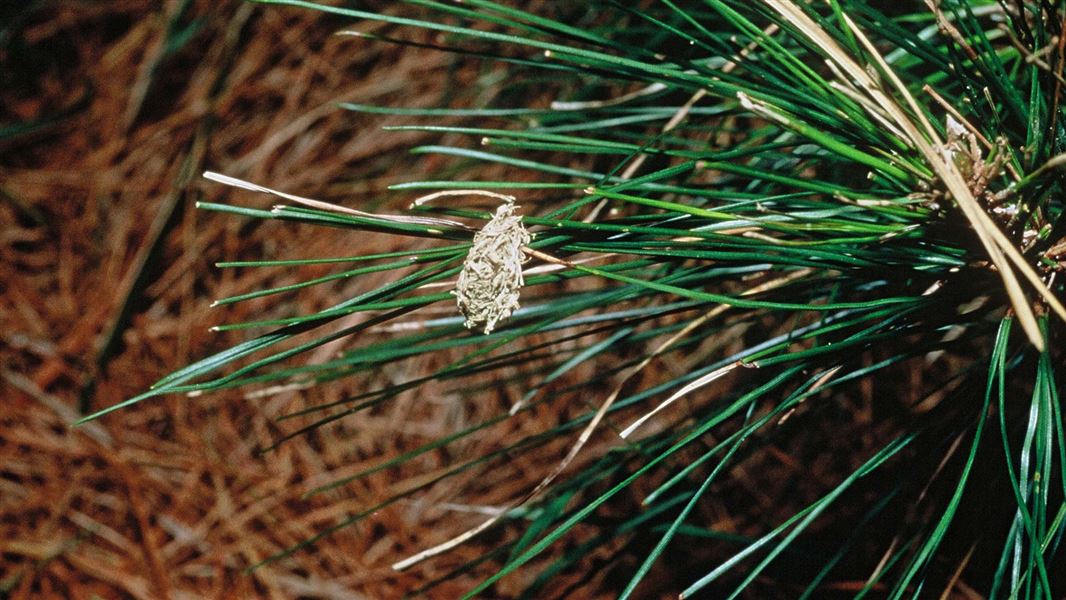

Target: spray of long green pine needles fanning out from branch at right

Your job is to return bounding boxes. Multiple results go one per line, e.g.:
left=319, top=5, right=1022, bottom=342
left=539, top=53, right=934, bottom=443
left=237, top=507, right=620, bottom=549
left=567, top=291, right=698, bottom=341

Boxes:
left=83, top=0, right=1066, bottom=598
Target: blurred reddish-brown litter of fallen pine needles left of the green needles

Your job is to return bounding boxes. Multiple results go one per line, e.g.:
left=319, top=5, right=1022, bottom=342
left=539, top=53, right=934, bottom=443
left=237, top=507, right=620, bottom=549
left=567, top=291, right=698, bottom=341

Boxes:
left=0, top=0, right=584, bottom=598
